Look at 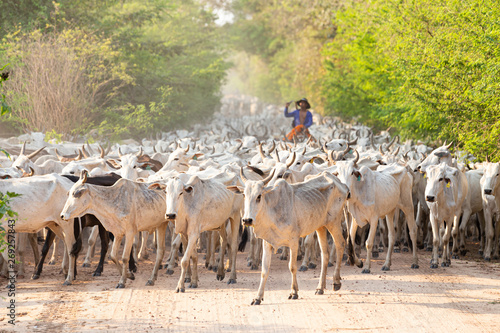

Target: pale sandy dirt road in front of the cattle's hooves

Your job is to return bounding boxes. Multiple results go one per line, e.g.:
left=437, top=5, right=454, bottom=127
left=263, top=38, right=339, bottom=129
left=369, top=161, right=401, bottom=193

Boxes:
left=0, top=240, right=500, bottom=332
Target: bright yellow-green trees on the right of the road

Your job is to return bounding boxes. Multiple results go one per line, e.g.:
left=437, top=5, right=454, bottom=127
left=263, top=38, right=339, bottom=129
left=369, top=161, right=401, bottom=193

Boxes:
left=323, top=0, right=500, bottom=159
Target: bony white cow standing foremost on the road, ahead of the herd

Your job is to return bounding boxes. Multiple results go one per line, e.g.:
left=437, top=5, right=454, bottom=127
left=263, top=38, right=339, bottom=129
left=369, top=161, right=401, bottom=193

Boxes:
left=228, top=169, right=349, bottom=305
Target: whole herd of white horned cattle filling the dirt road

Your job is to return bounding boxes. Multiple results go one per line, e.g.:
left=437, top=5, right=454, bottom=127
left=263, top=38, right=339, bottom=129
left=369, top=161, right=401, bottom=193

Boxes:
left=0, top=98, right=500, bottom=304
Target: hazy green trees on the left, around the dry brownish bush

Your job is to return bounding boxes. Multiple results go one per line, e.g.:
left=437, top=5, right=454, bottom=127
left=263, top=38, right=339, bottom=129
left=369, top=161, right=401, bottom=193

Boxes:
left=3, top=0, right=228, bottom=137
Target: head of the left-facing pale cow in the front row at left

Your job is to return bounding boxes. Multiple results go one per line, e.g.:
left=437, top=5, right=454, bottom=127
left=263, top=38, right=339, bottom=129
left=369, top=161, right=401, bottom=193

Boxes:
left=61, top=171, right=91, bottom=221
